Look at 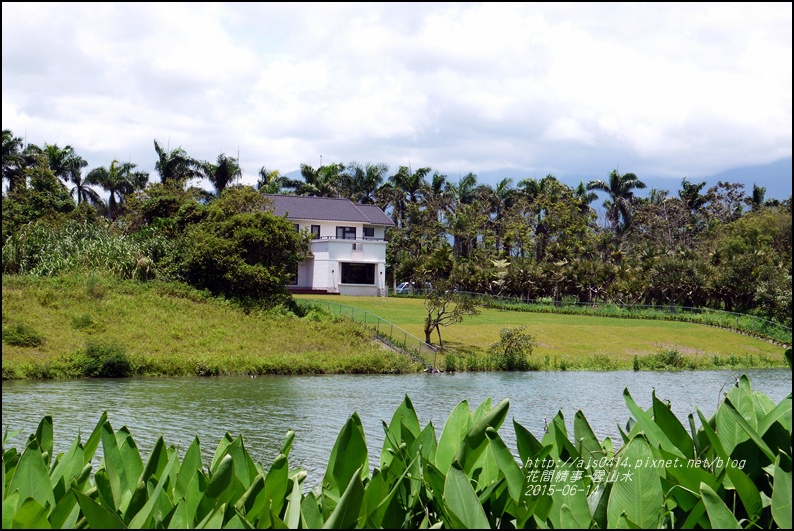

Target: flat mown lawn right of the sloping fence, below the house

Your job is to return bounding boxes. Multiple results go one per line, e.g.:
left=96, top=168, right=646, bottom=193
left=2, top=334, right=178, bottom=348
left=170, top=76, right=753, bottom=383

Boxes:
left=296, top=295, right=787, bottom=370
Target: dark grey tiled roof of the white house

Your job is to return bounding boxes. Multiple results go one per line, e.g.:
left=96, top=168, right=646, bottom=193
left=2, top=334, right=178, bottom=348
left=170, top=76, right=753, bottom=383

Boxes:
left=265, top=194, right=394, bottom=227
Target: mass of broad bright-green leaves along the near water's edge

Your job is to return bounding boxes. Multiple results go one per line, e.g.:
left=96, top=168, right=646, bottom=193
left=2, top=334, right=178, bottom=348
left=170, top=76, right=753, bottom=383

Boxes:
left=2, top=376, right=792, bottom=529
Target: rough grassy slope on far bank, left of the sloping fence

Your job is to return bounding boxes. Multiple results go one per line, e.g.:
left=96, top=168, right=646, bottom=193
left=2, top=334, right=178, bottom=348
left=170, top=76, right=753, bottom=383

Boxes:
left=2, top=274, right=423, bottom=379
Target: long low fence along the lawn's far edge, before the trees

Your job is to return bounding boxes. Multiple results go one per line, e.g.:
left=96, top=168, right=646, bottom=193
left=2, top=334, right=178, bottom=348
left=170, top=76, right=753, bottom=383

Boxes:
left=390, top=290, right=792, bottom=346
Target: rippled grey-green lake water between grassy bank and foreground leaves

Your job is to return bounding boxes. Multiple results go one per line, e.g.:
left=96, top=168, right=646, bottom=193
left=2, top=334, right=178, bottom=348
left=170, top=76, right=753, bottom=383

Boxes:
left=2, top=369, right=791, bottom=486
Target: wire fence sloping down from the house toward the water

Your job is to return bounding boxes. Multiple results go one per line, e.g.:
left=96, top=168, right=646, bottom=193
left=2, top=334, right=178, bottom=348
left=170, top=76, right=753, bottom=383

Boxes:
left=295, top=299, right=438, bottom=371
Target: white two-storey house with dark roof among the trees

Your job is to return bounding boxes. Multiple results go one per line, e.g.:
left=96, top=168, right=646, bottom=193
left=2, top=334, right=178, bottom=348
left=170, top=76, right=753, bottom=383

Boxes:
left=266, top=195, right=394, bottom=297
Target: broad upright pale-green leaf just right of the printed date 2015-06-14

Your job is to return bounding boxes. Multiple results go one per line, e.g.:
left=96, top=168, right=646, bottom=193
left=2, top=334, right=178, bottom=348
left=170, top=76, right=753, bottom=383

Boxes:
left=607, top=435, right=664, bottom=529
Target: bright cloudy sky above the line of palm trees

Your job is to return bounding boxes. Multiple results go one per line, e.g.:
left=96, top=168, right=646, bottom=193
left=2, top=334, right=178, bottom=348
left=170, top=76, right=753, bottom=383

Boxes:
left=2, top=2, right=792, bottom=194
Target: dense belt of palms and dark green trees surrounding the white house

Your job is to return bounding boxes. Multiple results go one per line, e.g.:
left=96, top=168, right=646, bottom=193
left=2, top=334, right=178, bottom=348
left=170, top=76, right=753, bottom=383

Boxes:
left=3, top=130, right=792, bottom=332
